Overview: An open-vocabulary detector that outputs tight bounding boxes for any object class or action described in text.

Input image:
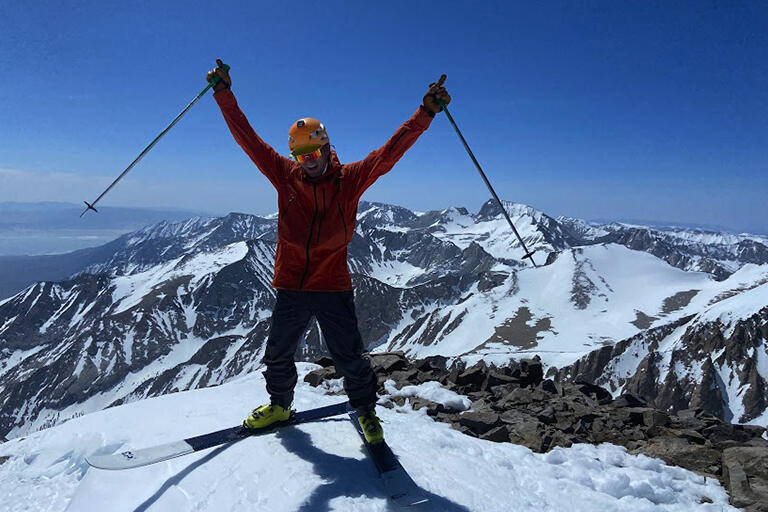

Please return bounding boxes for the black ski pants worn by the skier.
[263,290,378,408]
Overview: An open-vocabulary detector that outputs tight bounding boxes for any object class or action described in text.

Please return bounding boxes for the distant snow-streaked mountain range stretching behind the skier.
[0,198,768,437]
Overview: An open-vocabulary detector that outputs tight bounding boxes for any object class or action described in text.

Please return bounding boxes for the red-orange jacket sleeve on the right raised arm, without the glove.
[346,107,432,195]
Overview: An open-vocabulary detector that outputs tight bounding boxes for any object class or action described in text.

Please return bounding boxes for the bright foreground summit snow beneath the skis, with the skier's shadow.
[0,364,736,512]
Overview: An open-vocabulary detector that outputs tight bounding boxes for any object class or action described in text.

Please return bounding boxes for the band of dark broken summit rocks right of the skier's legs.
[305,352,768,512]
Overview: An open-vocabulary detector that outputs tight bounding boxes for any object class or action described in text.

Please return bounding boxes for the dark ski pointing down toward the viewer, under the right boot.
[347,407,429,507]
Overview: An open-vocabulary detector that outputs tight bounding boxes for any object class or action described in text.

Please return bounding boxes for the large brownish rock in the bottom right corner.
[722,447,768,512]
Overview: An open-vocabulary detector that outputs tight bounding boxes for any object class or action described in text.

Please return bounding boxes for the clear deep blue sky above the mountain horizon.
[0,0,768,233]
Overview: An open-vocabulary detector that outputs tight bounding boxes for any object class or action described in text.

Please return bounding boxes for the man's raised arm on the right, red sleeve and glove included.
[347,75,451,195]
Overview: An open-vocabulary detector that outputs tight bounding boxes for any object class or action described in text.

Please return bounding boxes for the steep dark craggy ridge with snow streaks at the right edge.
[551,306,768,423]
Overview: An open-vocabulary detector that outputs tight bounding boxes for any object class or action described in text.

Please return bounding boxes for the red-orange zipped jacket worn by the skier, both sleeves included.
[214,89,432,291]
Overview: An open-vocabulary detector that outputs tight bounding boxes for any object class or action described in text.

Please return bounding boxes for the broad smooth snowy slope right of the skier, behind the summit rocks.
[382,244,768,367]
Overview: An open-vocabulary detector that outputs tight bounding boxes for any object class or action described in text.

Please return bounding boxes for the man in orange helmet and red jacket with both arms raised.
[206,60,451,443]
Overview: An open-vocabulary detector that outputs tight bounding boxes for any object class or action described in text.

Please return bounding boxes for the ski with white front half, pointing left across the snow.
[85,402,347,470]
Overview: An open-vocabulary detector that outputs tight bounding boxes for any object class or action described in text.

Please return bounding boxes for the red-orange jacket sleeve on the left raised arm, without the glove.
[213,89,293,189]
